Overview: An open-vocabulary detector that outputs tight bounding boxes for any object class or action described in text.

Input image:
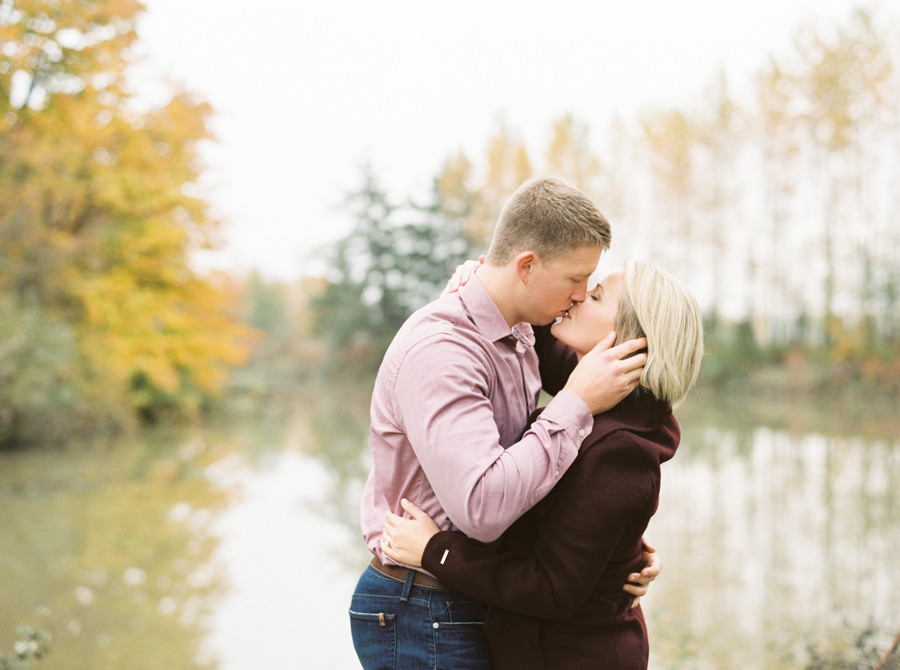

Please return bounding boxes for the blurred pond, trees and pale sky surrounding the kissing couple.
[0,0,900,670]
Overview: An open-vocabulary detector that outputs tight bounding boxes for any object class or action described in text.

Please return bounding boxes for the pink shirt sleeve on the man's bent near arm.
[393,341,593,542]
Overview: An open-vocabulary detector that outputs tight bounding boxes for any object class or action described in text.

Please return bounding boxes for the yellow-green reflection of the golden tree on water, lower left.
[0,432,232,669]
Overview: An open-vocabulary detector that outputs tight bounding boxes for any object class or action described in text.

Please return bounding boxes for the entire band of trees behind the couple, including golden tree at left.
[0,5,900,448]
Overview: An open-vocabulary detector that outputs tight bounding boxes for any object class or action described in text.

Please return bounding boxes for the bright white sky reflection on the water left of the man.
[208,451,368,670]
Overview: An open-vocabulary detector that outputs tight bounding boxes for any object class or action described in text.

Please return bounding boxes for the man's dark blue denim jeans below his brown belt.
[350,566,491,670]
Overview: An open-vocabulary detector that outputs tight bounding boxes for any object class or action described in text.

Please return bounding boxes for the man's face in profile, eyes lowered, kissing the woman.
[528,246,601,325]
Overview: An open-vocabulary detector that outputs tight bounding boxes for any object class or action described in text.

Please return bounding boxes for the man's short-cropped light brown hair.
[487,176,612,267]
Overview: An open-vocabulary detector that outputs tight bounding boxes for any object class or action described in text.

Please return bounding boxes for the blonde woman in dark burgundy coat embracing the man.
[382,261,703,670]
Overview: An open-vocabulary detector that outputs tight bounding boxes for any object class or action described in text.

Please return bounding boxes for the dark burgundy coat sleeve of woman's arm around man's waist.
[422,433,657,619]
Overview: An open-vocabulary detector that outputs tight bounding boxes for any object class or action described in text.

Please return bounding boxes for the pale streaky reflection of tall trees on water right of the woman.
[647,428,900,668]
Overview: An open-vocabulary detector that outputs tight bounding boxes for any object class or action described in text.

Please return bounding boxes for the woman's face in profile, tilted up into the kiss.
[552,272,623,358]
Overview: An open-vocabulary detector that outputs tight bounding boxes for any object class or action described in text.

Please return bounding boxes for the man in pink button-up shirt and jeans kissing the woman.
[350,177,658,670]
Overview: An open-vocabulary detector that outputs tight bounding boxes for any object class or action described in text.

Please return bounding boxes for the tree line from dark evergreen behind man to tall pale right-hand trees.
[316,10,900,388]
